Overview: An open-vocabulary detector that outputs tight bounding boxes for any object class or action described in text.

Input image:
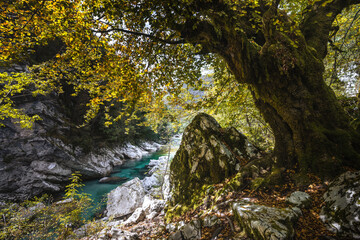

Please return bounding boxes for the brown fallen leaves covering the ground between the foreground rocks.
[131,172,337,240]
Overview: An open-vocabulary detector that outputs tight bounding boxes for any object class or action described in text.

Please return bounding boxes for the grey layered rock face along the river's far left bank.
[0,94,159,201]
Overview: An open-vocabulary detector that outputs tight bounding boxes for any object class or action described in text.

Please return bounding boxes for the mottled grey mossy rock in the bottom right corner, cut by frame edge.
[320,172,360,239]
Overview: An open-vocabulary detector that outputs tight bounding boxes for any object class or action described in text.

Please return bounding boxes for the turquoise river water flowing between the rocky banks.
[80,151,167,218]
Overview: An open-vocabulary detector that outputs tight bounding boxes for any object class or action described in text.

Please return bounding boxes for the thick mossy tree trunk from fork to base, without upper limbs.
[221,30,360,178]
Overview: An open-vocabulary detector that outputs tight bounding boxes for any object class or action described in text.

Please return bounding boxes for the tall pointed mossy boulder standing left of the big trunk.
[170,113,258,204]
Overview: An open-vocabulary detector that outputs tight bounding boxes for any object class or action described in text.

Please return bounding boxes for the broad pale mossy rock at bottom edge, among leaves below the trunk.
[232,200,301,240]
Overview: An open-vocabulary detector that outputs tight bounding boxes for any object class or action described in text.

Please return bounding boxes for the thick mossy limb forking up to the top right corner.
[300,0,360,59]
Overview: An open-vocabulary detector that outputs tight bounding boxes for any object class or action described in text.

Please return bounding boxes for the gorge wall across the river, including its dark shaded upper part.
[0,66,159,201]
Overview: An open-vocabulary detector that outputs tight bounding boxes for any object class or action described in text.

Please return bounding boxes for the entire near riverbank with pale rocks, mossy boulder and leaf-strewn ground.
[76,115,360,240]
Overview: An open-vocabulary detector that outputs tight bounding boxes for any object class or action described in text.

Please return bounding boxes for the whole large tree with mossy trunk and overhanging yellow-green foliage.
[0,0,360,177]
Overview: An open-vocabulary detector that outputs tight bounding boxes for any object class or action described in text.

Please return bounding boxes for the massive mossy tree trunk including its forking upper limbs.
[181,0,360,178]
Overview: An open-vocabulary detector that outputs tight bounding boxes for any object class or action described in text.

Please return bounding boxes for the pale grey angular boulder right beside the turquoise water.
[106,178,145,218]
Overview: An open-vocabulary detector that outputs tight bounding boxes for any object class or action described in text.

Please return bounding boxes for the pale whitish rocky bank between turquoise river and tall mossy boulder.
[71,156,170,239]
